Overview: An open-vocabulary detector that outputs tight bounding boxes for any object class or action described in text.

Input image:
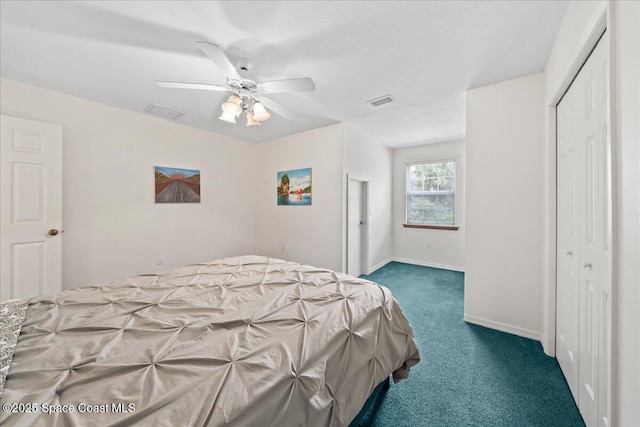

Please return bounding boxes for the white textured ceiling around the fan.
[0,0,568,147]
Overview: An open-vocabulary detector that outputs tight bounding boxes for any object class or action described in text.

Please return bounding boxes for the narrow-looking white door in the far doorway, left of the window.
[347,177,368,277]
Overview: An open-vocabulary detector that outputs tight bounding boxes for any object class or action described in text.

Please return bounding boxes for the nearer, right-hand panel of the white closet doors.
[578,30,611,426]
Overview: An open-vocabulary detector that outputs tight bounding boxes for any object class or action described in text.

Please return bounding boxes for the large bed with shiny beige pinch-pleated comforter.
[0,256,420,426]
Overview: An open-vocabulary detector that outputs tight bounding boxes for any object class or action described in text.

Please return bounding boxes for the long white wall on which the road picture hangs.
[0,79,255,289]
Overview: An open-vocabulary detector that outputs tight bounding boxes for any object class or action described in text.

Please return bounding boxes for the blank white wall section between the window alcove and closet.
[465,74,542,339]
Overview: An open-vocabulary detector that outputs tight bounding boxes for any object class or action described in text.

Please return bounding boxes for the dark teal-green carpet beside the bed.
[362,262,584,427]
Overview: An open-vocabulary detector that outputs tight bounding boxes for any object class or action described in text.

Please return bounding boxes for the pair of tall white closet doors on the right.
[557,33,611,426]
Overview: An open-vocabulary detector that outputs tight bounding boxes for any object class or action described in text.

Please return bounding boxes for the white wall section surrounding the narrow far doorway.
[342,123,393,271]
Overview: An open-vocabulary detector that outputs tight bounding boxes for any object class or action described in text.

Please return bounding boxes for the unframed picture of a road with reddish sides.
[155,166,200,203]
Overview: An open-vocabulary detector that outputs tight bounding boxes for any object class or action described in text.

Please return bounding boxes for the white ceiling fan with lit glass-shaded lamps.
[157,41,316,126]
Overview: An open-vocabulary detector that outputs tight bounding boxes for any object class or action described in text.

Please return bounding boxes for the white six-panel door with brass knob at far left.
[0,115,62,301]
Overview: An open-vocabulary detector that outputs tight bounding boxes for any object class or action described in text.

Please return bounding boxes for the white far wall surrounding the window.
[393,141,465,271]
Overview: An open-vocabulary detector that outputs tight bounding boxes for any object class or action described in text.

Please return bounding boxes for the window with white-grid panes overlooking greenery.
[406,160,456,226]
